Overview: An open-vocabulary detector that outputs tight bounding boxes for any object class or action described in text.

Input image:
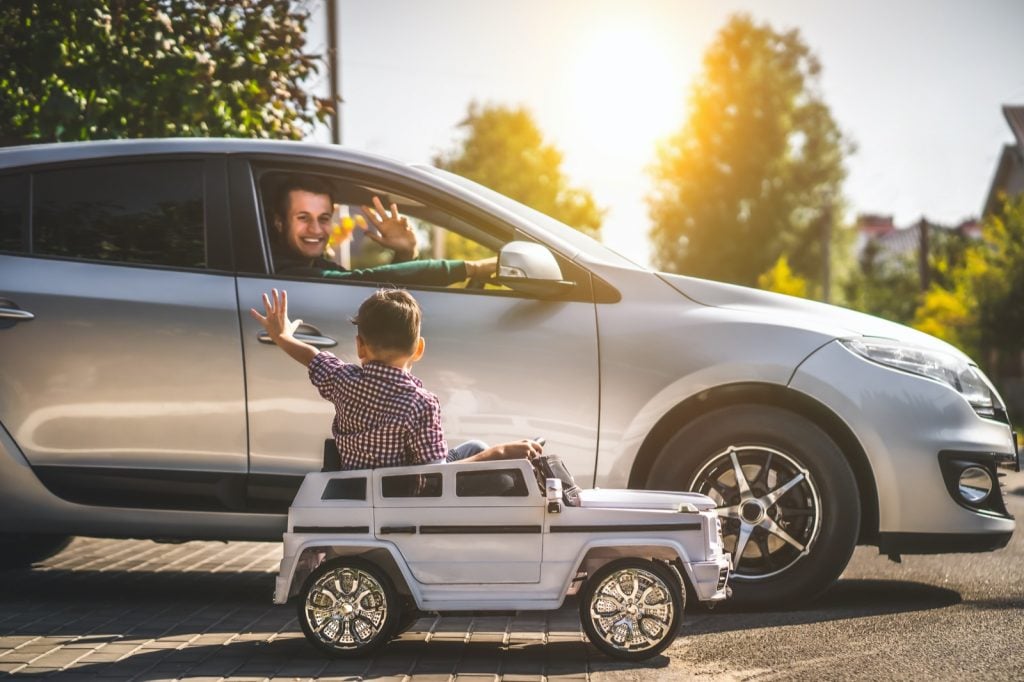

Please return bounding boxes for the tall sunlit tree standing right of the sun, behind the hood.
[648,15,852,288]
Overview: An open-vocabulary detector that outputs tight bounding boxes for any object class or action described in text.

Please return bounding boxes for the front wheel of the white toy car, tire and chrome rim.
[580,558,685,660]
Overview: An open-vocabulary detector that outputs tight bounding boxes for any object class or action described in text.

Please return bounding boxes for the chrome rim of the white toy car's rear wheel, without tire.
[303,566,389,651]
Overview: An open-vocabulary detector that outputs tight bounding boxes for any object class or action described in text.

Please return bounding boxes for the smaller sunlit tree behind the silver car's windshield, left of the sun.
[434,102,604,240]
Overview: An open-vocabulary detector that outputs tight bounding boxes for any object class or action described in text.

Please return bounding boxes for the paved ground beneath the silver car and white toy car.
[0,466,1024,682]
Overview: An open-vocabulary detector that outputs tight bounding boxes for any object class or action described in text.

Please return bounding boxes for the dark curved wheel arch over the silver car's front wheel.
[629,383,879,545]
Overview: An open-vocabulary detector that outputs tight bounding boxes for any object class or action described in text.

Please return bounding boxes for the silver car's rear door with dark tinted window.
[0,156,248,509]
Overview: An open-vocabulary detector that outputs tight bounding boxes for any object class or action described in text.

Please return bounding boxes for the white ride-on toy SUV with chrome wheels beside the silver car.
[274,450,730,659]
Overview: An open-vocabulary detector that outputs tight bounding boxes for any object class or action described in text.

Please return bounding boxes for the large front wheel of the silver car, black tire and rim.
[647,404,860,607]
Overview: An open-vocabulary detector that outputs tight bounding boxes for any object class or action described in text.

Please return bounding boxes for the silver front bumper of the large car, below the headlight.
[790,342,1018,540]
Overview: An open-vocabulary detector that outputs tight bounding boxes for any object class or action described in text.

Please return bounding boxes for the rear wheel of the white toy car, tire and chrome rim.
[298,559,401,657]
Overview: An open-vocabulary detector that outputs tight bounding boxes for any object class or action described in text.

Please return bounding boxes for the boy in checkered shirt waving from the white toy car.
[250,289,542,470]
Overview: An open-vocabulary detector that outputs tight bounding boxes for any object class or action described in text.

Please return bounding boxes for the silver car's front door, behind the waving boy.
[231,155,598,505]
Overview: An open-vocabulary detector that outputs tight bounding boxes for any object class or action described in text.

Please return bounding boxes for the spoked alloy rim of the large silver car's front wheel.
[690,445,821,582]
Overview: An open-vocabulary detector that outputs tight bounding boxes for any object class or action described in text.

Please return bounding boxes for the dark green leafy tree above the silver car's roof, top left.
[0,0,333,143]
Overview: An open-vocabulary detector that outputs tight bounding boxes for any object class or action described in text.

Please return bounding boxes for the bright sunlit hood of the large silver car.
[657,272,964,357]
